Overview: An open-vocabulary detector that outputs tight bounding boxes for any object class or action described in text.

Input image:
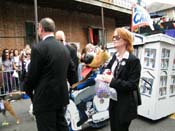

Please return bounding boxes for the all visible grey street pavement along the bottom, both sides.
[0,99,175,131]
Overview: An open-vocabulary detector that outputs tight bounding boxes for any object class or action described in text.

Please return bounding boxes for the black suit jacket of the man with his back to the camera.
[25,37,70,113]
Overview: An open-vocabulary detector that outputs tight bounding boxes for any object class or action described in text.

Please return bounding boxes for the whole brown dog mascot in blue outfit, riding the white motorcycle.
[72,44,109,126]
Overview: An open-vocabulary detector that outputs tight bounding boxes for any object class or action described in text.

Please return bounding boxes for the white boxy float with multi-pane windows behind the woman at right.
[134,34,175,120]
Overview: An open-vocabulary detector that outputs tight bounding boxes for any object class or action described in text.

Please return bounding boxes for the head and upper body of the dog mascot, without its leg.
[72,44,109,90]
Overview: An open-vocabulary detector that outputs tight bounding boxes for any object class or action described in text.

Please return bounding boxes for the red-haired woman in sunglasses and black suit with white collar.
[103,28,141,131]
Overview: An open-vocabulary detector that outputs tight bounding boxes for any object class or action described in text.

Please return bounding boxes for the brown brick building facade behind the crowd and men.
[0,0,131,52]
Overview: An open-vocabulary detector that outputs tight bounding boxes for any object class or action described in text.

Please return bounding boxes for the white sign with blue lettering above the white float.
[131,5,154,31]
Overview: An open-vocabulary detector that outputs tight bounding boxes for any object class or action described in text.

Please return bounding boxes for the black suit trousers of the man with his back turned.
[35,108,69,131]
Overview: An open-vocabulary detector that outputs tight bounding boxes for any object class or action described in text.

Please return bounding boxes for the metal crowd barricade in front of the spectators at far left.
[0,70,21,96]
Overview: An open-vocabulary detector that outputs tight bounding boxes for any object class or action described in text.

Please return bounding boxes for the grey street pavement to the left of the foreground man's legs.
[0,99,37,131]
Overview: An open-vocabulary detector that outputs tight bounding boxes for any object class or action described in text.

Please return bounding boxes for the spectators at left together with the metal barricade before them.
[0,45,31,94]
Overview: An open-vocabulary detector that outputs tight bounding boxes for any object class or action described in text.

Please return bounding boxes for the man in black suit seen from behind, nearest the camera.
[25,18,70,131]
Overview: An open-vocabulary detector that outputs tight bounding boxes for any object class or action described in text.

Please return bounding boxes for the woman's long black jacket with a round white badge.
[107,54,141,122]
